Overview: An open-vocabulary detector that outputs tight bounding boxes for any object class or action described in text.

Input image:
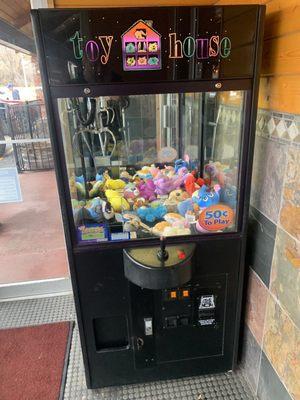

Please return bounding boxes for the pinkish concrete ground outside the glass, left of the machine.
[0,170,69,284]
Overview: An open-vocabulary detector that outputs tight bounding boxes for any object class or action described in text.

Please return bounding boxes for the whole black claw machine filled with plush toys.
[32,5,264,388]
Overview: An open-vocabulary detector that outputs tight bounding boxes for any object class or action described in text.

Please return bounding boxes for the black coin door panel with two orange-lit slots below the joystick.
[130,275,226,368]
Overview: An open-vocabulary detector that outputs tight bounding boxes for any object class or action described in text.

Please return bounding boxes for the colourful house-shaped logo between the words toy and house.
[122,20,162,71]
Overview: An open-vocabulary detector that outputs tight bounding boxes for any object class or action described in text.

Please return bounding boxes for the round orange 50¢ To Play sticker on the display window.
[199,204,234,231]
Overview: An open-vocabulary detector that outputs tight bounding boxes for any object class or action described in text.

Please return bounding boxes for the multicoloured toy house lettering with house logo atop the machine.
[70,20,231,71]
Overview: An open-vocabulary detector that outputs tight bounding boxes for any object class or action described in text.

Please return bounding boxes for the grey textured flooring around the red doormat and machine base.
[0,296,255,400]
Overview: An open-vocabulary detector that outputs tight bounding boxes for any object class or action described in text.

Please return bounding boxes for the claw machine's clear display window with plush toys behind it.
[58,91,245,244]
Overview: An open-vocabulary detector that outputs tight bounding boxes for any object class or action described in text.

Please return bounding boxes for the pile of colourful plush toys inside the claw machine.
[70,159,237,236]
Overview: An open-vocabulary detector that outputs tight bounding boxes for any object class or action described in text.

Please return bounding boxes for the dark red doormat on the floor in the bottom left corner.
[0,321,74,400]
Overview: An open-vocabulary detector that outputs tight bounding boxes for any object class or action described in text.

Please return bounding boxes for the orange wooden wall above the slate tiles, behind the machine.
[54,0,300,114]
